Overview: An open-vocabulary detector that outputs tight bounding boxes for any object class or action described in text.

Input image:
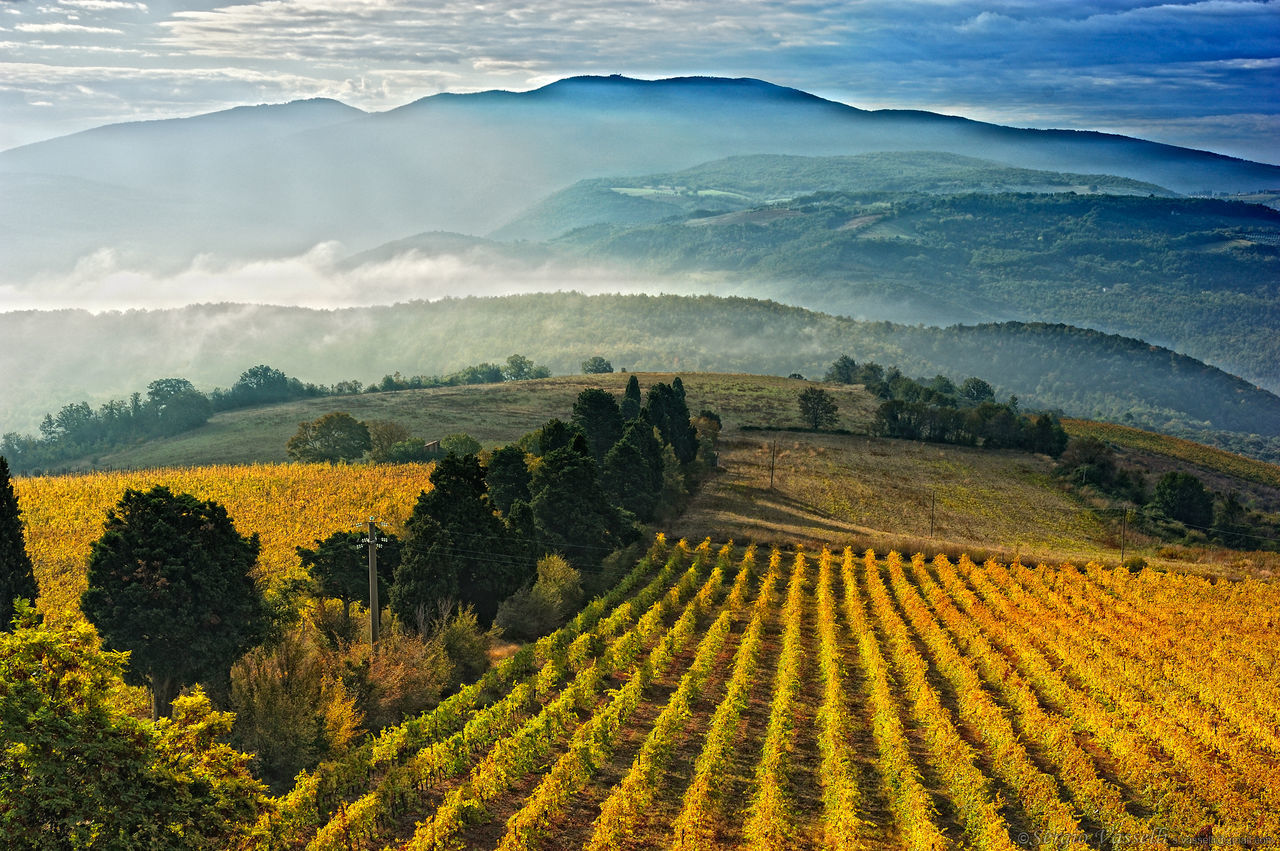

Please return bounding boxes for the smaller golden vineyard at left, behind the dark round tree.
[14,465,431,621]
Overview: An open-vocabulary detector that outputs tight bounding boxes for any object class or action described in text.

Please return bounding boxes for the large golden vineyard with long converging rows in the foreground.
[256,536,1280,850]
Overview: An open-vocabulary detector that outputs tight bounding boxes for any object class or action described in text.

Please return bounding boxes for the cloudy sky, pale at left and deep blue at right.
[0,0,1280,163]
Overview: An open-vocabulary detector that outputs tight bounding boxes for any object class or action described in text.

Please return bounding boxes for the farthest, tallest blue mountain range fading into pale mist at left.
[0,77,1280,279]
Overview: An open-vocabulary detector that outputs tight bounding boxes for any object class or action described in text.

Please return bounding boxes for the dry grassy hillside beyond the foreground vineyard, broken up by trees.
[57,372,1280,578]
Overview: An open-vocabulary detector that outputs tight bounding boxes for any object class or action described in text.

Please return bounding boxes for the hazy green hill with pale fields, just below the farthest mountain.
[493,151,1172,241]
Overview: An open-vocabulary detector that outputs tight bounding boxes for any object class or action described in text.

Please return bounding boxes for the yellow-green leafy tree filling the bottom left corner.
[0,604,266,850]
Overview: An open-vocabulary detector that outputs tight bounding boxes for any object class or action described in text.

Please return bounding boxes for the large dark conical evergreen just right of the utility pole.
[390,454,532,627]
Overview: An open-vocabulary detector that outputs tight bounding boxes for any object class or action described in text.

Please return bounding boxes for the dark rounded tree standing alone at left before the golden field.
[81,486,270,717]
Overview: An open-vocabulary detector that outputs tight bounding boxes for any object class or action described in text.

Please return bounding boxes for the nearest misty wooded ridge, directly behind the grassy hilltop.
[0,293,1280,458]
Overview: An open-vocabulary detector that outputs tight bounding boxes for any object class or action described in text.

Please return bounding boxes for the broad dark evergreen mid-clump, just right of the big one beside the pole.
[530,447,621,567]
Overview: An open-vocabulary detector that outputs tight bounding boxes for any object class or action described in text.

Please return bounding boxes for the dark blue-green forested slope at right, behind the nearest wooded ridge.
[552,193,1280,389]
